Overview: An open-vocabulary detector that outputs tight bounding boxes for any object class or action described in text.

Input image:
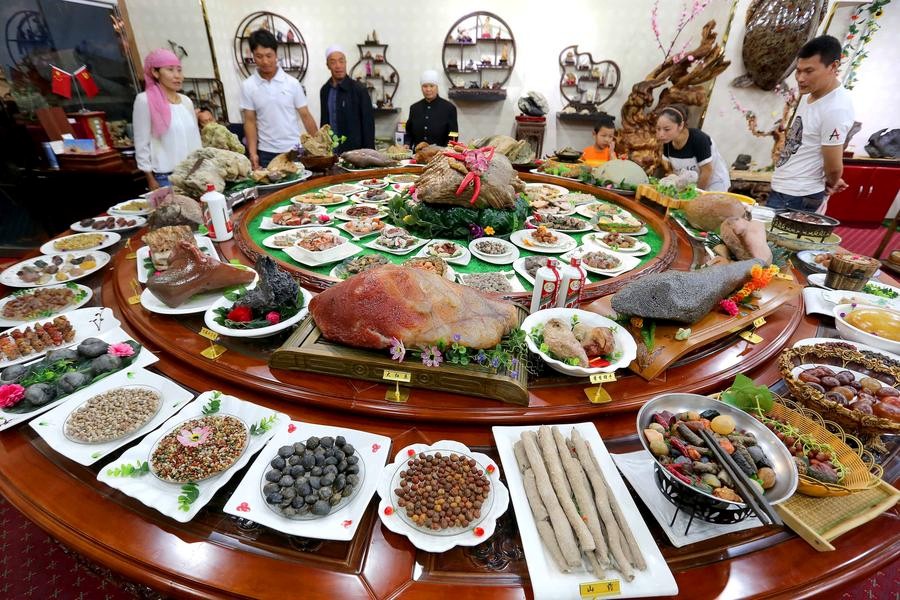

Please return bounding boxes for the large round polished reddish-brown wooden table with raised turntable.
[0,171,900,599]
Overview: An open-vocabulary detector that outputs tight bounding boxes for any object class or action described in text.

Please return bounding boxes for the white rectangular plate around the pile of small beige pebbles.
[30,369,194,465]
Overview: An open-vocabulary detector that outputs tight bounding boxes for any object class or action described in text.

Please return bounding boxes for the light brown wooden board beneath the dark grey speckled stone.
[586,278,802,381]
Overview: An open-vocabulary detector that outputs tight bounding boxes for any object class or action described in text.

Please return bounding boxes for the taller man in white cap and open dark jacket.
[319,44,375,153]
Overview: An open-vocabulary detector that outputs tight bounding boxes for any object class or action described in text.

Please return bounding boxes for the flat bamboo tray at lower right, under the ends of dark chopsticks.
[775,479,900,552]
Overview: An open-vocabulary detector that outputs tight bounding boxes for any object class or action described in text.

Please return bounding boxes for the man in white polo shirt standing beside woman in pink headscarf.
[241,29,318,169]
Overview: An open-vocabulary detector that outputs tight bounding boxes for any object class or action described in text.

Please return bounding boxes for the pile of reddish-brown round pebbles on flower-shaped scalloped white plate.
[394,452,491,531]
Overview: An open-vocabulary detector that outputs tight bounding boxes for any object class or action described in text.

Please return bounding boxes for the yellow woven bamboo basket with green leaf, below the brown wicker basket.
[766,397,884,498]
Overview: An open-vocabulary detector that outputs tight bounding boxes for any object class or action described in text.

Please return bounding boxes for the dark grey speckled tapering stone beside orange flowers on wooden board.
[612,259,763,323]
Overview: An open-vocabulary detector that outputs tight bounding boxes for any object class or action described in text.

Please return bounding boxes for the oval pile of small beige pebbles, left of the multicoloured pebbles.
[65,386,162,444]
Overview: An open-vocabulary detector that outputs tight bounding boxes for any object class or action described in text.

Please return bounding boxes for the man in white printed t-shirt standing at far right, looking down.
[766,35,853,211]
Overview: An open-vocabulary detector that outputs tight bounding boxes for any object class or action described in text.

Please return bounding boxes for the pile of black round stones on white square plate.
[262,435,362,518]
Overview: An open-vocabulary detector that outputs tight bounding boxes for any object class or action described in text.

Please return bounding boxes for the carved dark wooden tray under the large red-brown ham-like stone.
[269,308,528,406]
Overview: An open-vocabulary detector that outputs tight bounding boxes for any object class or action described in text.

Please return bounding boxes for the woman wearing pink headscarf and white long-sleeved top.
[132,49,200,190]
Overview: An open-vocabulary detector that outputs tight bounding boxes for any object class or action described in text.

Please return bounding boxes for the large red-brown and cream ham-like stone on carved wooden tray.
[309,264,518,349]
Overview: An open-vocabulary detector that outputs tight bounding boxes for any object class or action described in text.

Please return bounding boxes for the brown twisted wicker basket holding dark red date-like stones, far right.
[778,344,900,447]
